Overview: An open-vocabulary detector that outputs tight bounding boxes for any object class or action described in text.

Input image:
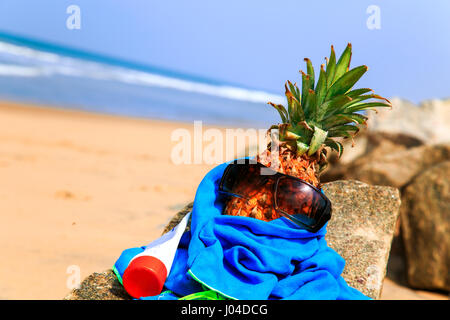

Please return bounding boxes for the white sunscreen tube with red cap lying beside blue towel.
[122,212,191,298]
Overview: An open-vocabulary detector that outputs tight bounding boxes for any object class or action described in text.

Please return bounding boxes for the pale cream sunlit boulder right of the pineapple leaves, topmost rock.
[368,98,450,144]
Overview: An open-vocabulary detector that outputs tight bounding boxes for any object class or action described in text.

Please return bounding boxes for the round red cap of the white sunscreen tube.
[122,256,167,299]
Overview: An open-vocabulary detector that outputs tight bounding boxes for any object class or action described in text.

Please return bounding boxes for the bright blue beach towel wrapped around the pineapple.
[114,163,370,300]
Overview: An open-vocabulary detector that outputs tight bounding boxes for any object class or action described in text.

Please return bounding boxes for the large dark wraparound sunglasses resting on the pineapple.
[219,160,331,232]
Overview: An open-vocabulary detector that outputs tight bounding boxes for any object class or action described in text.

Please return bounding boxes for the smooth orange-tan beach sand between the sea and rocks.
[0,102,444,299]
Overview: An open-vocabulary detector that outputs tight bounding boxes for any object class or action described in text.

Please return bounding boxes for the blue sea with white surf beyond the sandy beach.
[0,32,285,128]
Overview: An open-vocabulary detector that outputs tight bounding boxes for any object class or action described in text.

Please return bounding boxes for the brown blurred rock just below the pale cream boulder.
[322,141,450,188]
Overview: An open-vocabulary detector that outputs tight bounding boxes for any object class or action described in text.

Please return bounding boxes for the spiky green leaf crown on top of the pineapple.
[269,43,391,170]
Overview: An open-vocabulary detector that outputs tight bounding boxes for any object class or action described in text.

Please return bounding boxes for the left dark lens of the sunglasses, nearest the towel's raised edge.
[221,164,274,198]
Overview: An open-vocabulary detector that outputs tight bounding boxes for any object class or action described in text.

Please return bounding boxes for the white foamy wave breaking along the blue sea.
[0,41,284,103]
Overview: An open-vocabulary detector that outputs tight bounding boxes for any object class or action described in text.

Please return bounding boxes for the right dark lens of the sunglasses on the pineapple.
[276,178,327,226]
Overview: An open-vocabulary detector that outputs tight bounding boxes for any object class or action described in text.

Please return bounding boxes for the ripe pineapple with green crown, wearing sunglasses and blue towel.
[224,43,391,221]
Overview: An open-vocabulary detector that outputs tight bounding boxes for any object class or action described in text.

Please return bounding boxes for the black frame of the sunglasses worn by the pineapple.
[219,162,332,232]
